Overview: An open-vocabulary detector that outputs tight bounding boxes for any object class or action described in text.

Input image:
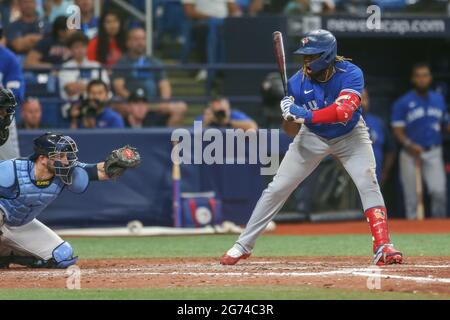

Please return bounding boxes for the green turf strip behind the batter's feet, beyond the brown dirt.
[67,234,450,259]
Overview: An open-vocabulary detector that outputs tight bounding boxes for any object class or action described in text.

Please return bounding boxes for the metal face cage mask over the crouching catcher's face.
[48,136,78,185]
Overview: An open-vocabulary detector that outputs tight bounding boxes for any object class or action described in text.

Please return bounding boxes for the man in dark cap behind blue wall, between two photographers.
[125,88,169,128]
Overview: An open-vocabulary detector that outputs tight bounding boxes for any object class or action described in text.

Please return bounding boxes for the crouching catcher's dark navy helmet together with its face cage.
[30,132,78,184]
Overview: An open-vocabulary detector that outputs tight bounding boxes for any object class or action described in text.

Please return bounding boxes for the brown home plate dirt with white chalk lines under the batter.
[0,257,450,295]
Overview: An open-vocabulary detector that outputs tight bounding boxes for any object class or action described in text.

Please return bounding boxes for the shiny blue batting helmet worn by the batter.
[294,29,337,73]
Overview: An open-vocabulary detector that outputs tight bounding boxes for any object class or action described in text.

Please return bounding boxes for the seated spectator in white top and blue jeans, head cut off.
[182,0,242,81]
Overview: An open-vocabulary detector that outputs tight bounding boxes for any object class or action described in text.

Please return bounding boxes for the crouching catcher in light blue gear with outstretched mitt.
[0,133,140,268]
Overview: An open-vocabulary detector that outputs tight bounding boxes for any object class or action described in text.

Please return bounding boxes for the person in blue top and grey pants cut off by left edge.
[0,24,25,160]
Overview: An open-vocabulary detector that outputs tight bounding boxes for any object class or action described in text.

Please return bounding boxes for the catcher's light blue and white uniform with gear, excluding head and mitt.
[0,135,96,268]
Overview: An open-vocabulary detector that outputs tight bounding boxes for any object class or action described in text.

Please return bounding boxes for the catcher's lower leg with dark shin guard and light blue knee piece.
[0,241,78,269]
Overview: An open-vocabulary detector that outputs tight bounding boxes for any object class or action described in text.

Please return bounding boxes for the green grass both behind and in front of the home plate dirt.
[0,234,450,300]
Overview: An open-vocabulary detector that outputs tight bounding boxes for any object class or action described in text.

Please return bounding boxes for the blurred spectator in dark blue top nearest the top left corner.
[6,0,48,54]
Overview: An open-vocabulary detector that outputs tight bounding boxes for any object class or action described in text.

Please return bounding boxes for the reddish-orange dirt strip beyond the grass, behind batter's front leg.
[271,219,450,235]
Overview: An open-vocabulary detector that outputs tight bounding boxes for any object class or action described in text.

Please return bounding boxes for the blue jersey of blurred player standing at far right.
[391,90,449,148]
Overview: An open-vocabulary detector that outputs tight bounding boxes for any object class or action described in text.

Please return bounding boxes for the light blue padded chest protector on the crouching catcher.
[0,160,64,226]
